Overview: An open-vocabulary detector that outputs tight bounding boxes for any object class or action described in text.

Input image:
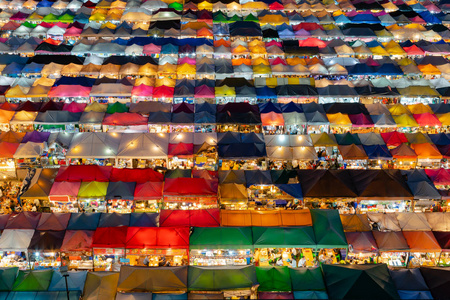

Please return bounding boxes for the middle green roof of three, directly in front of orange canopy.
[252,226,316,248]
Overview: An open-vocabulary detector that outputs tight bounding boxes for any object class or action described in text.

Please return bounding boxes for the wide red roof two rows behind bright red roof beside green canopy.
[164,177,218,196]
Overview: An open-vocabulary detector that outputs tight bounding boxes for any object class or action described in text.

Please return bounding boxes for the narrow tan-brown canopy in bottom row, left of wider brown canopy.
[83,272,119,300]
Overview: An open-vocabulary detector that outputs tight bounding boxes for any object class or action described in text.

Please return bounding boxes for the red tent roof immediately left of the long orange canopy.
[159,209,220,227]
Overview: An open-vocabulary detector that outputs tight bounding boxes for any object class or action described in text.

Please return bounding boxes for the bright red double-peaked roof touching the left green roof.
[126,227,189,249]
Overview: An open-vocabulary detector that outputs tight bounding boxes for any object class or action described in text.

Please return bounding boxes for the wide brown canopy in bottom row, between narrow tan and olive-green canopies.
[118,266,188,292]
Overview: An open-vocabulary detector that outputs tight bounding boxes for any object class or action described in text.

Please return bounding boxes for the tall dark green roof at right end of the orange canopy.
[310,209,348,248]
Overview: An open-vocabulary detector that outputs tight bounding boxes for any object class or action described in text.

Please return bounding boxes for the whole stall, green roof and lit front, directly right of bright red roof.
[189,227,253,266]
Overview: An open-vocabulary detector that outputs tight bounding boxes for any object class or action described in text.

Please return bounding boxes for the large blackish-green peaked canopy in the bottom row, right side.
[322,264,399,299]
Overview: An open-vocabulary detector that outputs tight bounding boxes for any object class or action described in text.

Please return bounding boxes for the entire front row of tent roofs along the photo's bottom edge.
[1,264,449,300]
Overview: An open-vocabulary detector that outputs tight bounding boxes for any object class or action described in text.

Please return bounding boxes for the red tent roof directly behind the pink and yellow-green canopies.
[55,165,112,182]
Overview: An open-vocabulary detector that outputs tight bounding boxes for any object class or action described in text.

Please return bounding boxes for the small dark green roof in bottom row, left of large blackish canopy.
[289,268,325,291]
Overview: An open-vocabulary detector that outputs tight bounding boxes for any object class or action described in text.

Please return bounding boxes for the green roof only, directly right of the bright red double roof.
[189,227,253,249]
